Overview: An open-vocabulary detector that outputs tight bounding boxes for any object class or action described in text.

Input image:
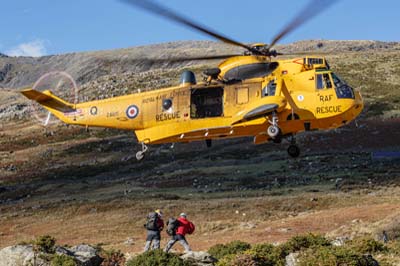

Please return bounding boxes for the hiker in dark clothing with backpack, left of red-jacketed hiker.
[144,210,164,252]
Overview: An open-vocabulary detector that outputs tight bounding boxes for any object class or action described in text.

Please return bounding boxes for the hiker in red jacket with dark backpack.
[164,213,195,252]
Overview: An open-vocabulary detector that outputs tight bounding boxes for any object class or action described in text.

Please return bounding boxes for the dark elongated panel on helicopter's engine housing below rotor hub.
[224,63,274,80]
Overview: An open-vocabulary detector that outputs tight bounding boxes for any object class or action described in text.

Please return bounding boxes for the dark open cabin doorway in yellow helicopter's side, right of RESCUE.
[190,87,224,118]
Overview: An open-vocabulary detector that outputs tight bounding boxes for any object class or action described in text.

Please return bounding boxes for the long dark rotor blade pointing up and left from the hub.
[121,0,253,51]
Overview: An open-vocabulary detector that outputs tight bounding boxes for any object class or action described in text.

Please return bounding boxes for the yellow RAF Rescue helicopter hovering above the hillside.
[21,0,363,160]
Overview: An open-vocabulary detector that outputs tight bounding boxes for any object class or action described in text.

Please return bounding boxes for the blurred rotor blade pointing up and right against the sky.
[268,0,338,50]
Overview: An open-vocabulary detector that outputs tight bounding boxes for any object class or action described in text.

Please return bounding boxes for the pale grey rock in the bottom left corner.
[0,245,49,266]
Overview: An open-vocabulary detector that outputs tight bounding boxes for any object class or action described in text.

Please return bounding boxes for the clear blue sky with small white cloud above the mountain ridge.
[0,0,400,56]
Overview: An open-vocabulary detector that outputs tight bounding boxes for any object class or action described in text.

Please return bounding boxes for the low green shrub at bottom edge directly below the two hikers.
[126,250,192,266]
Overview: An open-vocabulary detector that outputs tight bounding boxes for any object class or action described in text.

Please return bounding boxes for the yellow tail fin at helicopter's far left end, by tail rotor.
[21,89,76,113]
